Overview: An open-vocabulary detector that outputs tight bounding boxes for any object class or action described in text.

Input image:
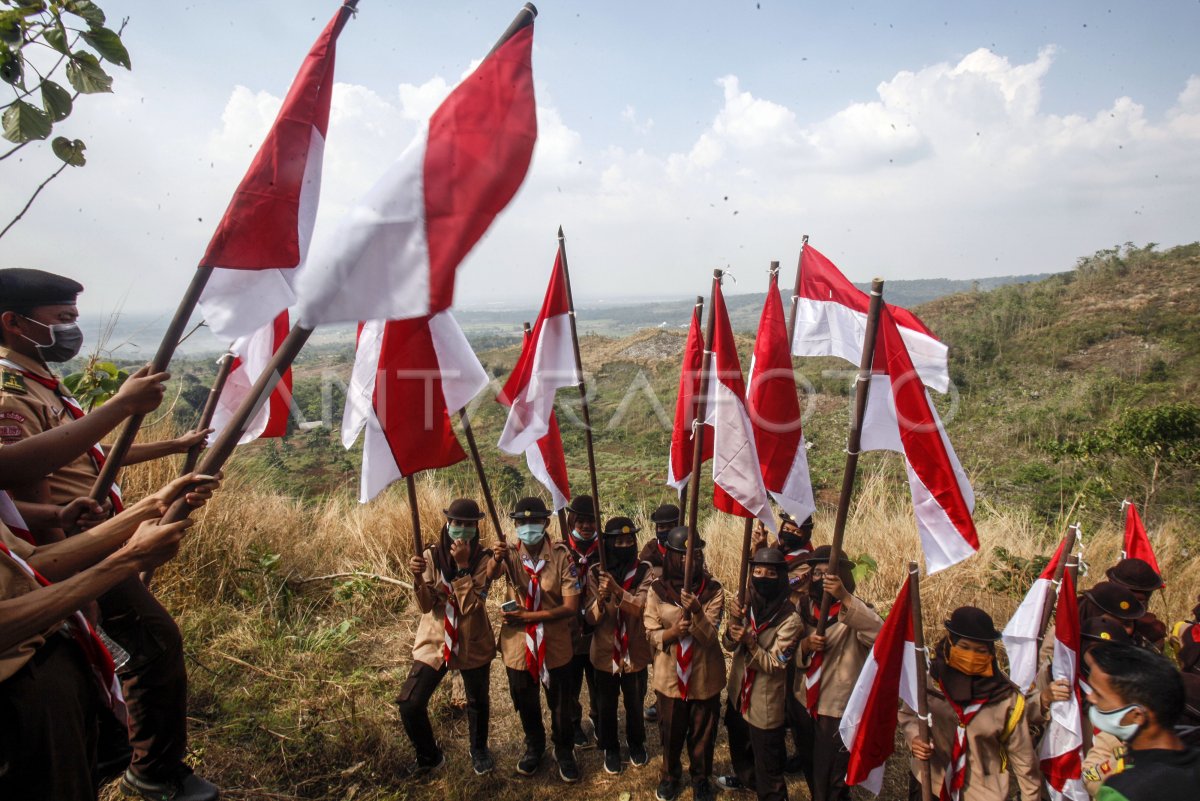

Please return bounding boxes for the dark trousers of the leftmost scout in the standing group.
[396,662,492,765]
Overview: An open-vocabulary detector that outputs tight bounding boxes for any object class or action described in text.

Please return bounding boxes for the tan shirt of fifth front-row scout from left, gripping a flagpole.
[646,579,725,700]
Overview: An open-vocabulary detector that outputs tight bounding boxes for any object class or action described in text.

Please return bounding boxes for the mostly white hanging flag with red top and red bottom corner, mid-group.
[704,282,779,531]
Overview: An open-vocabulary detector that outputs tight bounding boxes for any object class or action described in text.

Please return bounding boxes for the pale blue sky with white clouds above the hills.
[0,0,1200,330]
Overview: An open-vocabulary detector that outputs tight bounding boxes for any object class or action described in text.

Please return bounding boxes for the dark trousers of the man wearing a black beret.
[98,577,187,779]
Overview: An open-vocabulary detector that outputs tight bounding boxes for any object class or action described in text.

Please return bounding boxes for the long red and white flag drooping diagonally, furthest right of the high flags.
[862,307,979,573]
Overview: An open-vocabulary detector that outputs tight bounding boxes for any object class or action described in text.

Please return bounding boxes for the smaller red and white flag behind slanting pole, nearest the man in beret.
[209,309,292,445]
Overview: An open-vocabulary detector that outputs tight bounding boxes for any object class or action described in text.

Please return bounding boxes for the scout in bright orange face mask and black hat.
[900,607,1042,801]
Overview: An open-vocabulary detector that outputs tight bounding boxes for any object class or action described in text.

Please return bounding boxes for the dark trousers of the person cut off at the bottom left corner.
[0,634,103,801]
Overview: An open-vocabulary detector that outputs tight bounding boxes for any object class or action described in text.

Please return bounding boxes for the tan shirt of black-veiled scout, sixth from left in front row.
[721,608,804,729]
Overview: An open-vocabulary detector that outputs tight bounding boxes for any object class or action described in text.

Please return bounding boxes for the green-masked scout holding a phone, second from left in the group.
[491,498,581,783]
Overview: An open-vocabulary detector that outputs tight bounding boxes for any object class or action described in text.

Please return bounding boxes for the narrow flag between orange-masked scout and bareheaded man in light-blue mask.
[1038,571,1090,801]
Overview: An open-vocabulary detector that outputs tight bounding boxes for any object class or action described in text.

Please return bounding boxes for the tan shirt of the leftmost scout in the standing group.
[413,548,496,670]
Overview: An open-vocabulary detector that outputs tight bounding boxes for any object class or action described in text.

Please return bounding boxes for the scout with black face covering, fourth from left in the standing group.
[583,517,653,773]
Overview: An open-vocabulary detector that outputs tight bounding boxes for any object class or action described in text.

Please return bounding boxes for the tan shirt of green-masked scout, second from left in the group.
[499,532,580,670]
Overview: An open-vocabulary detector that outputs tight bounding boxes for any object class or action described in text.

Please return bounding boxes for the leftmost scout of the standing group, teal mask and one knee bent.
[397,498,496,776]
